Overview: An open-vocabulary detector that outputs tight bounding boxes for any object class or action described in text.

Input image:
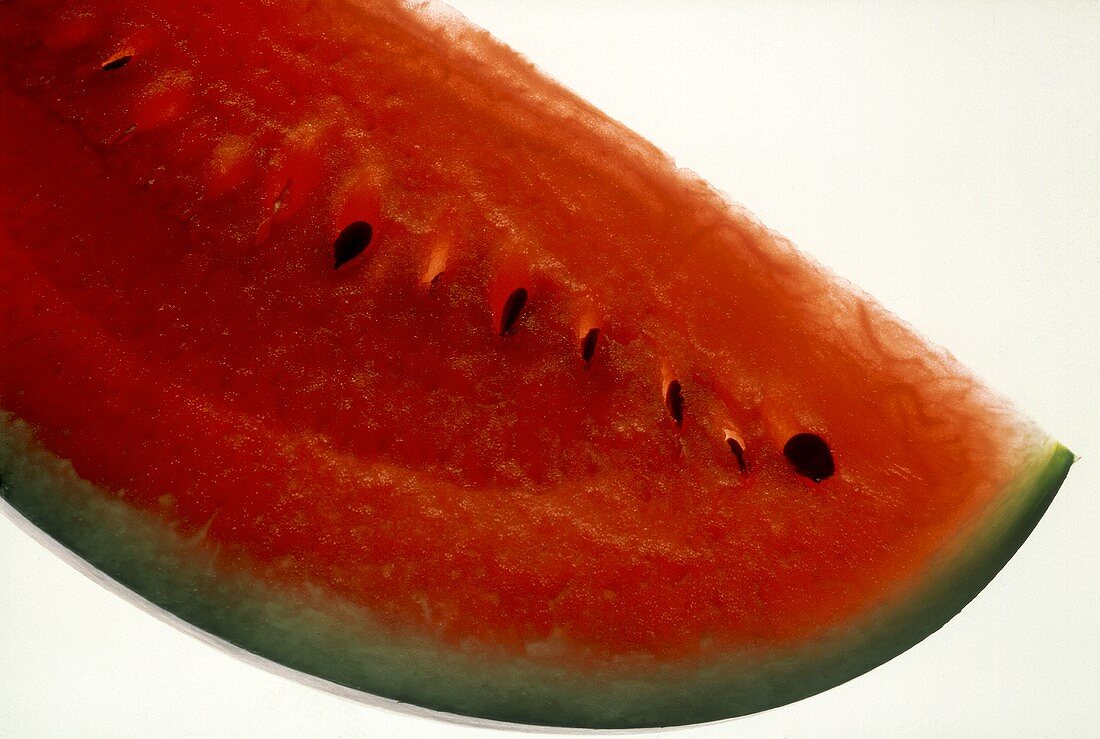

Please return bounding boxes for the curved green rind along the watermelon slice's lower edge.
[0,412,1075,728]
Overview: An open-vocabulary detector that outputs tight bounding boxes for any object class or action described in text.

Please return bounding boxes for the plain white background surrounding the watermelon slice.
[0,0,1100,739]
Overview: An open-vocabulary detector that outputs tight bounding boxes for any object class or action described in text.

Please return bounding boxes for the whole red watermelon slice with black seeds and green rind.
[0,0,1073,727]
